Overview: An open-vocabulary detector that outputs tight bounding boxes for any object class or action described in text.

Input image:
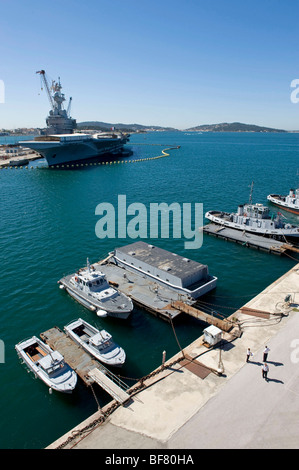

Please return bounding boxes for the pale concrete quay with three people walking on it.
[47,264,299,450]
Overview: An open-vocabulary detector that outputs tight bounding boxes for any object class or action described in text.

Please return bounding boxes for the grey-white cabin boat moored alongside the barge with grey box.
[58,258,133,319]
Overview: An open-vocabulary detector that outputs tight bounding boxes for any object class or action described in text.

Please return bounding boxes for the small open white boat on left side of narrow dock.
[15,336,77,393]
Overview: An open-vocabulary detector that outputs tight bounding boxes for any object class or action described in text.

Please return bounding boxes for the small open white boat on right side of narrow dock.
[64,318,126,366]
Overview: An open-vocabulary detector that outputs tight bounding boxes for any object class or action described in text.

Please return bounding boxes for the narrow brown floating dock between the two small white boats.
[40,326,130,403]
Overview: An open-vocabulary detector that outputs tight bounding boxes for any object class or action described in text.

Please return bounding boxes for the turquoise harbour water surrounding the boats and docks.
[0,132,299,449]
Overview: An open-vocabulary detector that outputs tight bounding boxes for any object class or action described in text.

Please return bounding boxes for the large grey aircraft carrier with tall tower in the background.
[18,70,129,166]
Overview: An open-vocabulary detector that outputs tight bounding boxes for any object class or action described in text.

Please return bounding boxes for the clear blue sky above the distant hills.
[0,0,299,130]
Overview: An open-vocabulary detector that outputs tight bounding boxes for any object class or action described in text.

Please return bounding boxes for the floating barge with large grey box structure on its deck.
[59,241,217,321]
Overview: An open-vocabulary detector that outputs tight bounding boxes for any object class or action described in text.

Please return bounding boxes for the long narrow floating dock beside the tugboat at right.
[202,223,299,255]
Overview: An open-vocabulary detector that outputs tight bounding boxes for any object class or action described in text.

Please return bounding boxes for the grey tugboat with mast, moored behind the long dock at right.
[205,183,299,241]
